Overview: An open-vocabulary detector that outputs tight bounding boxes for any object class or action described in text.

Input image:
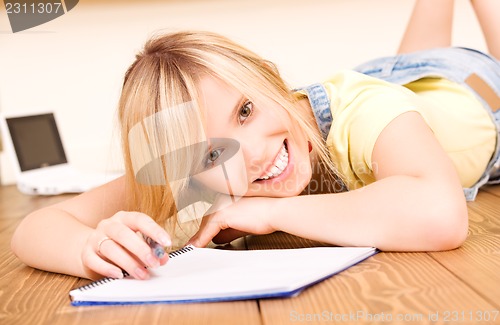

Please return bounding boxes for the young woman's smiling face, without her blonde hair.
[198,76,312,197]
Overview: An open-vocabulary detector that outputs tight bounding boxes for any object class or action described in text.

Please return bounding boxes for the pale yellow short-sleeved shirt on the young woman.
[324,71,496,190]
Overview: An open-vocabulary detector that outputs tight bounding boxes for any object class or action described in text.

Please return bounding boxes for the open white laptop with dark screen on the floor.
[0,112,119,195]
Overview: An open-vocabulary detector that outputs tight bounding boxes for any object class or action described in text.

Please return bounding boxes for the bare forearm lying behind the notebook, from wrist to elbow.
[272,176,467,251]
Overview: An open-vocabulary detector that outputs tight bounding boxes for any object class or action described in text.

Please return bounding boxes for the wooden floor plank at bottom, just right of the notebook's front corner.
[260,253,495,324]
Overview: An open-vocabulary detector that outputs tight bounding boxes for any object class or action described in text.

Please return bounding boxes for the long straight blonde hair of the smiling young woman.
[119,31,340,235]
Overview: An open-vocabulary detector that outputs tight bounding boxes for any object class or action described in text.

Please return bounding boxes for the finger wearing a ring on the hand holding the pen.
[96,235,149,280]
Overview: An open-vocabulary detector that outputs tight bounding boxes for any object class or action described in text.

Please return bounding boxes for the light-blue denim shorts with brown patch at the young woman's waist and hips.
[354,47,500,201]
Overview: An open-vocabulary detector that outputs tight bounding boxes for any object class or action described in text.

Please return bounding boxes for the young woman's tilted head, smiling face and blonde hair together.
[118,31,334,233]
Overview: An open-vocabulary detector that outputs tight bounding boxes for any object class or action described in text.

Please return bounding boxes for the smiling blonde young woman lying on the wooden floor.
[12,0,500,279]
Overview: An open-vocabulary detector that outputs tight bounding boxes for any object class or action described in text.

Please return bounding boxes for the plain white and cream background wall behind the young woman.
[0,0,485,184]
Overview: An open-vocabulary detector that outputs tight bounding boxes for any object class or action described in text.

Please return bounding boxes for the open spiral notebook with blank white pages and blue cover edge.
[69,246,377,306]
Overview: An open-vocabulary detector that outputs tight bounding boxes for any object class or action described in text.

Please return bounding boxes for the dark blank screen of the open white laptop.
[6,113,67,171]
